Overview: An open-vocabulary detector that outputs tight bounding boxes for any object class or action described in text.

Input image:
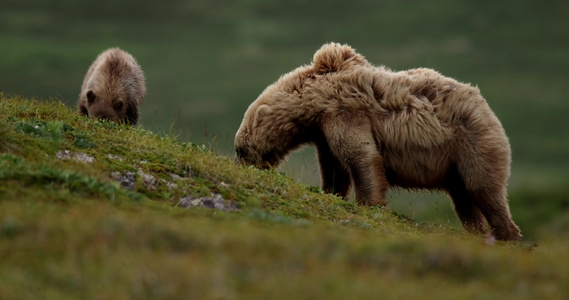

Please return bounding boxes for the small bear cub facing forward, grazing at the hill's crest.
[78,48,146,125]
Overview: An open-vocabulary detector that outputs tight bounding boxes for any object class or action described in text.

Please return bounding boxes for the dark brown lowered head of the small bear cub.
[79,90,138,125]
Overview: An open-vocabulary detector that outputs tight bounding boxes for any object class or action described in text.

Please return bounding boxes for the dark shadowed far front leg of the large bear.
[316,142,352,198]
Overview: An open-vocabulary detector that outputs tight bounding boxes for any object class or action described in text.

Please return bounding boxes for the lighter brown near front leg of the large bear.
[324,116,389,206]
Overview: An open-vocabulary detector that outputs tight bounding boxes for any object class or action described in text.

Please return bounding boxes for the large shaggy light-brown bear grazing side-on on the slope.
[235,43,521,240]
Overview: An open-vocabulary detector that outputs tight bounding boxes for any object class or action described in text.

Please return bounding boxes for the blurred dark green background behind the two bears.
[0,0,569,237]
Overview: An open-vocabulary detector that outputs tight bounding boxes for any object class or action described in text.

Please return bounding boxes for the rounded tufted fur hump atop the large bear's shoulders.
[312,43,368,74]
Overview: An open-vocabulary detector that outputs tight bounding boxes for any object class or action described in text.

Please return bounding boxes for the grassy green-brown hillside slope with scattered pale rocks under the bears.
[0,94,569,299]
